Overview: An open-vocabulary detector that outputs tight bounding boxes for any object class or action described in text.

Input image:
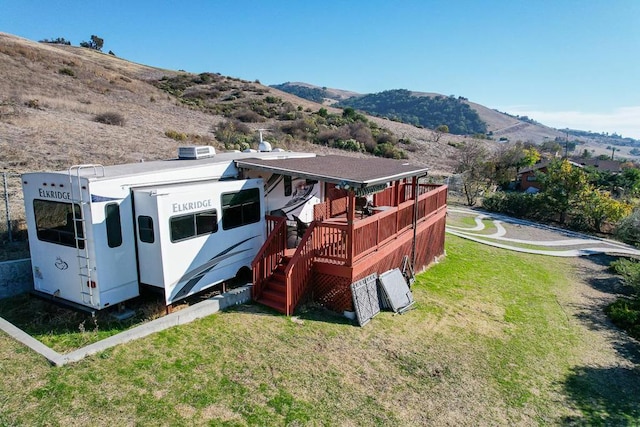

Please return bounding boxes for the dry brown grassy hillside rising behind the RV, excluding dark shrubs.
[0,33,500,175]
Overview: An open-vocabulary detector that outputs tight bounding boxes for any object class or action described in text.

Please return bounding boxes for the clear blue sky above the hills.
[0,0,640,138]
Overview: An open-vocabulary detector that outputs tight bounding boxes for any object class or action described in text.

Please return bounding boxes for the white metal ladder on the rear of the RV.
[69,164,104,307]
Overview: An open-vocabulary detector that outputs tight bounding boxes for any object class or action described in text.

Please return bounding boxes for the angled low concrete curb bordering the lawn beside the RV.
[0,285,252,366]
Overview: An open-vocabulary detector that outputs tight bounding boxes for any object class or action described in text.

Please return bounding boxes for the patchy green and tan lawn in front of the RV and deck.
[0,236,640,426]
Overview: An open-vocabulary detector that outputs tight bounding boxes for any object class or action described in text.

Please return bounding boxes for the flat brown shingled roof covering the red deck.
[236,155,427,191]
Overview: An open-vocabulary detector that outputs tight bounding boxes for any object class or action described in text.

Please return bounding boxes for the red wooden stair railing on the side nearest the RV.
[251,215,287,299]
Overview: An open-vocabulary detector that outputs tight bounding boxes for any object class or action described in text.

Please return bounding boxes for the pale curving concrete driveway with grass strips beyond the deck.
[446,208,640,257]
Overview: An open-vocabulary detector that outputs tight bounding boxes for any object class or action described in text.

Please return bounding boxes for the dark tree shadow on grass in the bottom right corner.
[563,367,640,425]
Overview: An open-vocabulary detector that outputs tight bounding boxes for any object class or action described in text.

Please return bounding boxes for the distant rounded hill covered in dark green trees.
[338,89,487,135]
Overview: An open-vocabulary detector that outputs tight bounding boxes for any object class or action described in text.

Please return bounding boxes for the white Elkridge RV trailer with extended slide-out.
[22,147,323,310]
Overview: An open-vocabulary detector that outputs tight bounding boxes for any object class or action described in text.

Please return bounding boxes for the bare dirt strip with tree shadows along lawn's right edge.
[559,255,640,425]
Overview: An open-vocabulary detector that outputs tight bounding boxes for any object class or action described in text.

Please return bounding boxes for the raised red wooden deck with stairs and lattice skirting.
[253,179,447,315]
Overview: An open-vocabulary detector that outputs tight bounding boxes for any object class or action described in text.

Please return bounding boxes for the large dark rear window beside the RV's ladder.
[33,199,84,249]
